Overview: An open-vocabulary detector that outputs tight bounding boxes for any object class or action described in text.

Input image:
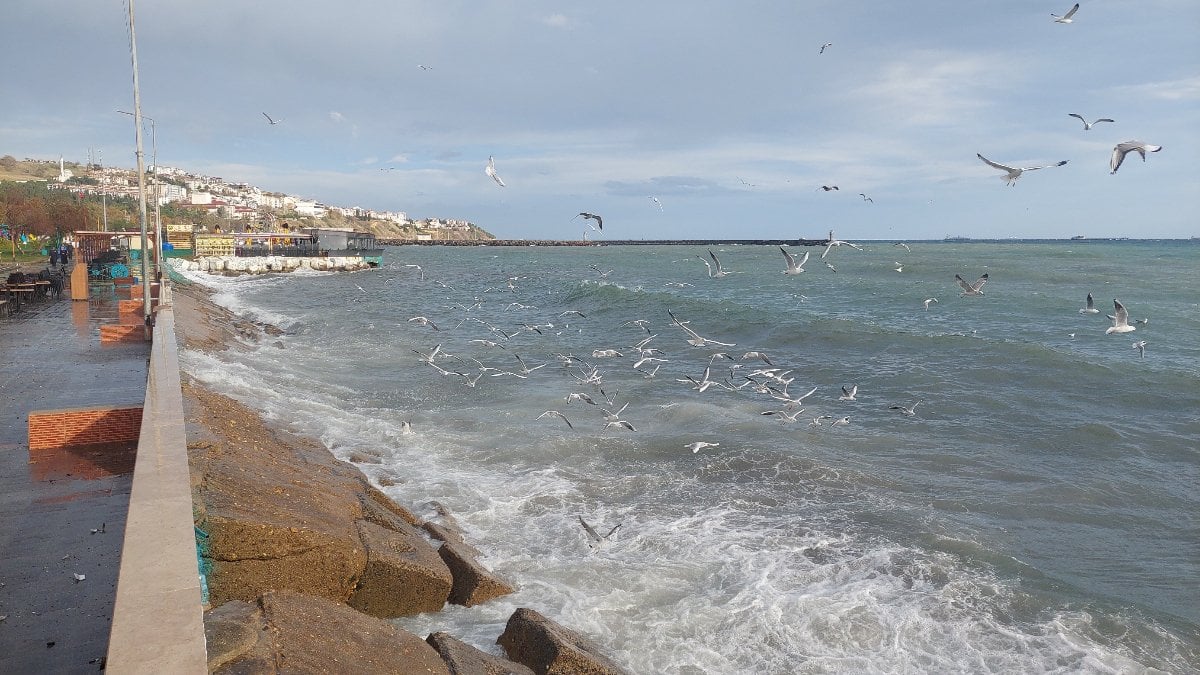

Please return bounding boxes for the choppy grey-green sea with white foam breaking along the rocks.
[175,240,1200,674]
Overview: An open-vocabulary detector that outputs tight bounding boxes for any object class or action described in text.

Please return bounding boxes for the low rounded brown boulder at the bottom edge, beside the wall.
[204,591,450,675]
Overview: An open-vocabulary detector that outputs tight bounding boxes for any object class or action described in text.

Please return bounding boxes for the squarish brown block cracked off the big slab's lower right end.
[348,520,455,617]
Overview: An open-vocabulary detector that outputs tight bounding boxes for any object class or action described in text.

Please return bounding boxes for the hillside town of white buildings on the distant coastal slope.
[9,157,492,240]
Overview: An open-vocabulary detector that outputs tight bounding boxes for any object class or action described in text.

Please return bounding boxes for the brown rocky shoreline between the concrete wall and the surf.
[174,285,624,674]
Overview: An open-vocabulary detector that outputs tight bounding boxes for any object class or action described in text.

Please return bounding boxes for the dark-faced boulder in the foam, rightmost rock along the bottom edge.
[496,608,625,675]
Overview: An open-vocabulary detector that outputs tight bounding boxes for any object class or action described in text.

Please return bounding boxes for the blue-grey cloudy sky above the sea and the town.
[0,0,1200,240]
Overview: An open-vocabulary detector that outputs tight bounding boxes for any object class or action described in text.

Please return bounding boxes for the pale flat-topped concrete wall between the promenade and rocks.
[107,302,208,674]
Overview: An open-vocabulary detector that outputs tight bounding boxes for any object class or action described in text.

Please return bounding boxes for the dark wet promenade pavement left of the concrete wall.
[0,273,150,673]
